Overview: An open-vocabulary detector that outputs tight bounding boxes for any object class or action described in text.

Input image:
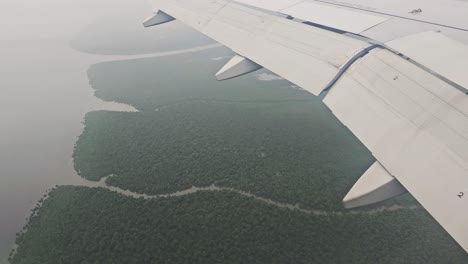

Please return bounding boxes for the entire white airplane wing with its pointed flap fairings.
[144,0,468,251]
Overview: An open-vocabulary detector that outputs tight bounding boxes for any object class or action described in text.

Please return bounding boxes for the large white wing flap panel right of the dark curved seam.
[324,49,468,249]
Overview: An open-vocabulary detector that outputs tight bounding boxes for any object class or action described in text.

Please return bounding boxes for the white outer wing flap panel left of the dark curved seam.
[148,0,370,95]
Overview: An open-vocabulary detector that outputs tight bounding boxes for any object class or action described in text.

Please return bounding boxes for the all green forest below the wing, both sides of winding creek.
[12,46,462,264]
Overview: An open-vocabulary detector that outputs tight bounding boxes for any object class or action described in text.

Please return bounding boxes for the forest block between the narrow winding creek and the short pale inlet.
[75,103,373,210]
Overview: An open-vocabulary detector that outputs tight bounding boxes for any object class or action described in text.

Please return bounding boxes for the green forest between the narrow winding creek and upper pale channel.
[74,49,416,210]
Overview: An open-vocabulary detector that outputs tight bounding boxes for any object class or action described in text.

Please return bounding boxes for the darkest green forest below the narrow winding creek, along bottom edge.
[12,187,468,264]
